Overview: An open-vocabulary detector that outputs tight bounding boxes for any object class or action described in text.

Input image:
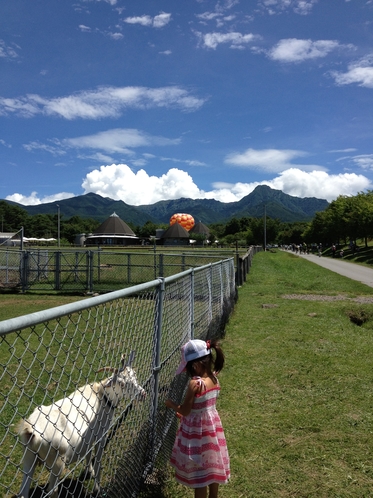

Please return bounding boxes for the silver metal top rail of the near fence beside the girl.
[0,258,233,336]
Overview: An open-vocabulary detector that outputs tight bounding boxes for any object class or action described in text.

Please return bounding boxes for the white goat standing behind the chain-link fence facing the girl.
[18,358,145,498]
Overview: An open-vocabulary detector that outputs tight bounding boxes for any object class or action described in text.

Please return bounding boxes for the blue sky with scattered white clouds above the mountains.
[0,0,373,205]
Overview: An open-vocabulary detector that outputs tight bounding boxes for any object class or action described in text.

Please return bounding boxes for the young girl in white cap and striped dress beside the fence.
[166,339,230,498]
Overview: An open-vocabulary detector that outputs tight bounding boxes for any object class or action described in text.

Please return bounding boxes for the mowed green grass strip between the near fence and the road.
[163,251,373,498]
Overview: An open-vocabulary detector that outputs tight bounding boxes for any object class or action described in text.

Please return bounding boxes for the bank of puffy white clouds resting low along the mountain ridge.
[6,164,372,206]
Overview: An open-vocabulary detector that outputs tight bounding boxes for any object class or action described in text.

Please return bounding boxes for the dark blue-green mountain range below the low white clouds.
[6,185,329,226]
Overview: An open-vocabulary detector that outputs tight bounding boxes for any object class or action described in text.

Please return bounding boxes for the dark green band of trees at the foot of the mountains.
[0,191,373,246]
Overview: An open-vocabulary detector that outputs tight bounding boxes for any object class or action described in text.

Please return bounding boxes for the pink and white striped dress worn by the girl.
[170,377,230,488]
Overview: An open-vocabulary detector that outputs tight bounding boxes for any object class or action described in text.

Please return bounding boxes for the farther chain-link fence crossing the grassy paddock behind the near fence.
[0,248,241,292]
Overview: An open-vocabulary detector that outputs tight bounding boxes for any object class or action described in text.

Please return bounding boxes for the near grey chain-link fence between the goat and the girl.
[0,258,236,498]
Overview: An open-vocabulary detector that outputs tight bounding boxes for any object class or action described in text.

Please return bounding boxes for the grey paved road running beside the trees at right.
[290,254,373,287]
